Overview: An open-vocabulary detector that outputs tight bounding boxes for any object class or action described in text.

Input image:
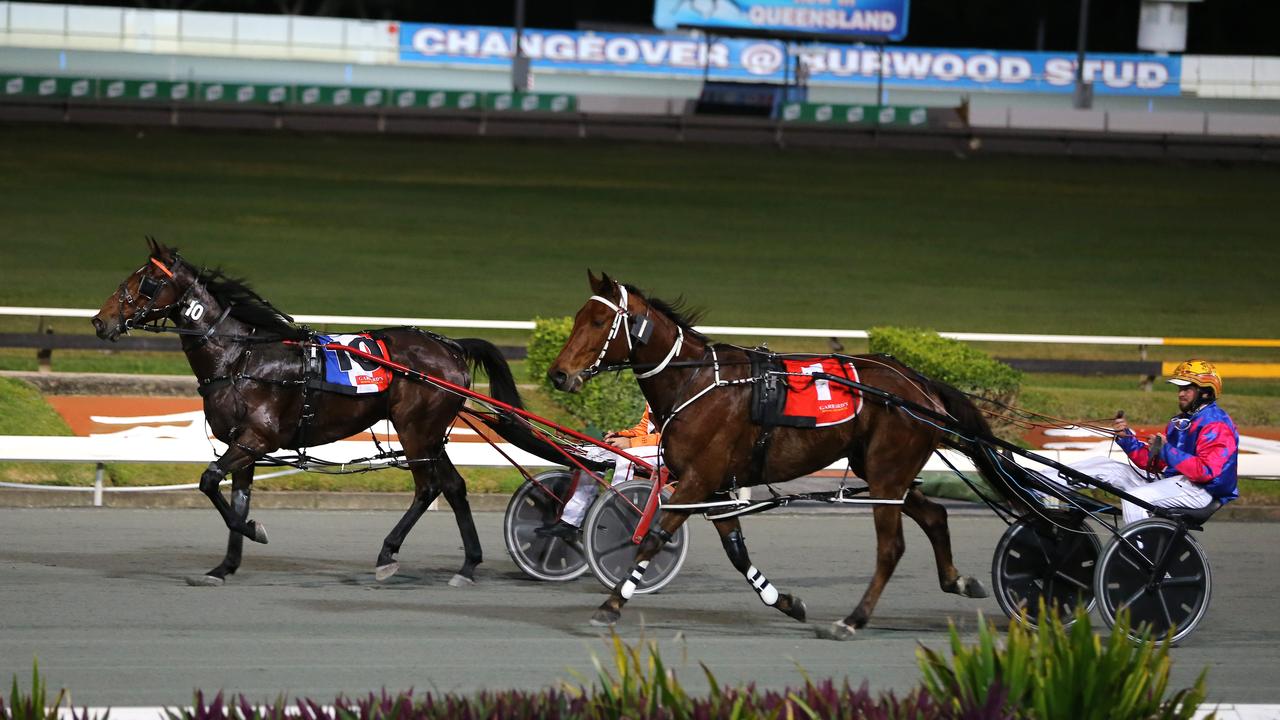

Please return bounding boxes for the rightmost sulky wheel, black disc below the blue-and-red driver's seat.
[1094,519,1213,643]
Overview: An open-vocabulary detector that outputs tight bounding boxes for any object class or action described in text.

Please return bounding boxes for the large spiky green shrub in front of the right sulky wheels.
[916,601,1204,720]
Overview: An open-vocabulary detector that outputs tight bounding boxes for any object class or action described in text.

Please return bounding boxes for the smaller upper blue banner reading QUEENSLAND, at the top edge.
[653,0,908,40]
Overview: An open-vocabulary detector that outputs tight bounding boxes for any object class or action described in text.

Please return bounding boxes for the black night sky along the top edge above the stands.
[55,0,1280,55]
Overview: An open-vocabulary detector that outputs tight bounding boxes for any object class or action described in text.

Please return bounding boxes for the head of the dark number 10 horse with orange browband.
[91,237,193,342]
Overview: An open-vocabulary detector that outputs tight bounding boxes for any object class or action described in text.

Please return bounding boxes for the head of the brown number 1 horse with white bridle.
[547,270,646,392]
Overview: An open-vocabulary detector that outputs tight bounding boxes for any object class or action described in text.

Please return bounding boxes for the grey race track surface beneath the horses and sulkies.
[0,509,1280,706]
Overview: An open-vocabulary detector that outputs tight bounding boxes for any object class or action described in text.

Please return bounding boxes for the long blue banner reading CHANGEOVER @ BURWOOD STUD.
[399,23,1181,96]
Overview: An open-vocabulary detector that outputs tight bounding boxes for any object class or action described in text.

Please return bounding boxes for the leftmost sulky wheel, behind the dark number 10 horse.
[502,469,586,582]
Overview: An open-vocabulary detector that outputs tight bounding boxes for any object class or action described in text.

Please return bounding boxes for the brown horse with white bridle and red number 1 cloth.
[548,273,1004,639]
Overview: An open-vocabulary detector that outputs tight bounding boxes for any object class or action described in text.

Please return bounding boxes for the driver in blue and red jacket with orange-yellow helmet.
[1071,360,1240,524]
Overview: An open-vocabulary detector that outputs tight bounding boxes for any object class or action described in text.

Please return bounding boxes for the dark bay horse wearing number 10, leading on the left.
[92,238,521,585]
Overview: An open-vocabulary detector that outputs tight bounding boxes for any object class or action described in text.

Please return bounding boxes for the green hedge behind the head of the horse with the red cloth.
[526,318,644,434]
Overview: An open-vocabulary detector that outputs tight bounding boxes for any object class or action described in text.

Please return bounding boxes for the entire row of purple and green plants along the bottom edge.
[0,611,1204,720]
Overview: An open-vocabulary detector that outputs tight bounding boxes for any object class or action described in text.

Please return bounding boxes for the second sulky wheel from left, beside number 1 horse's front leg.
[582,480,689,594]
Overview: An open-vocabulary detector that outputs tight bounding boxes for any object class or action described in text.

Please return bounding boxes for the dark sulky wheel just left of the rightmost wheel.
[991,518,1102,628]
